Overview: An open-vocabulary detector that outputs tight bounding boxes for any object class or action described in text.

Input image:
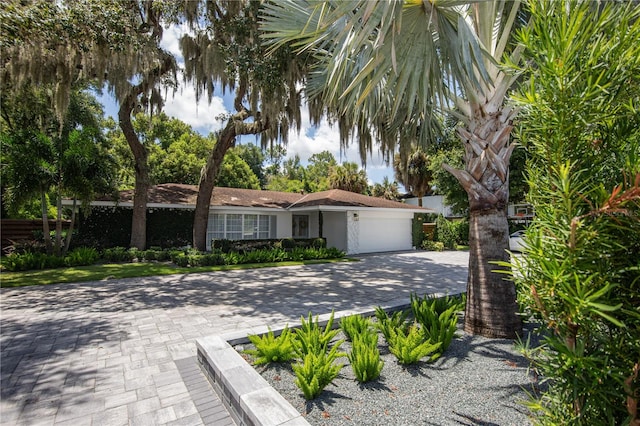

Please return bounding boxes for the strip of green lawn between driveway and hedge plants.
[0,259,351,287]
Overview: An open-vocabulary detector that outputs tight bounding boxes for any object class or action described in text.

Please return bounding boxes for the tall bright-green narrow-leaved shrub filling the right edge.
[513,0,640,425]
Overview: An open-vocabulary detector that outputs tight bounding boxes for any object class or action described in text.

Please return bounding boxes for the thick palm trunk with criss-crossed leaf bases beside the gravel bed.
[443,108,522,339]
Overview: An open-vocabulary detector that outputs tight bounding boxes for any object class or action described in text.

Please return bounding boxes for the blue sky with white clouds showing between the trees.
[98,26,395,184]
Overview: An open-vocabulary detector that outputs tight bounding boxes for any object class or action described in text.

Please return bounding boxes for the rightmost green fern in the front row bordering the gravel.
[387,324,442,364]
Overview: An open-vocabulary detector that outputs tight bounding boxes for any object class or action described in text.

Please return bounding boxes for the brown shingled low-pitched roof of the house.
[97,183,421,210]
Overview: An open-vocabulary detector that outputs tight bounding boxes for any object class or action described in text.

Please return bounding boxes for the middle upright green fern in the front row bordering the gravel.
[343,327,384,383]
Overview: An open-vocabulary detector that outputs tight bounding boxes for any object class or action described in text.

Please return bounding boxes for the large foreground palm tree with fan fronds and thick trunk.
[263,0,521,338]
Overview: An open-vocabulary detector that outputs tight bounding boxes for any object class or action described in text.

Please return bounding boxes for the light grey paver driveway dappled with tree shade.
[0,252,468,426]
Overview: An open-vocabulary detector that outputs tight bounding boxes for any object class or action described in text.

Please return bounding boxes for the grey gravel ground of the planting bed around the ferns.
[237,322,537,426]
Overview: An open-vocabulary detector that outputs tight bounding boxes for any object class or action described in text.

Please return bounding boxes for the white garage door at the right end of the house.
[359,211,413,253]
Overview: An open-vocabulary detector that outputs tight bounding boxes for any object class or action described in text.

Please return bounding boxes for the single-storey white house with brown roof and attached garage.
[79,184,430,254]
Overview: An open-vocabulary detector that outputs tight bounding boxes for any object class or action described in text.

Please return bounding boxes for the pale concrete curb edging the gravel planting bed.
[196,293,456,426]
